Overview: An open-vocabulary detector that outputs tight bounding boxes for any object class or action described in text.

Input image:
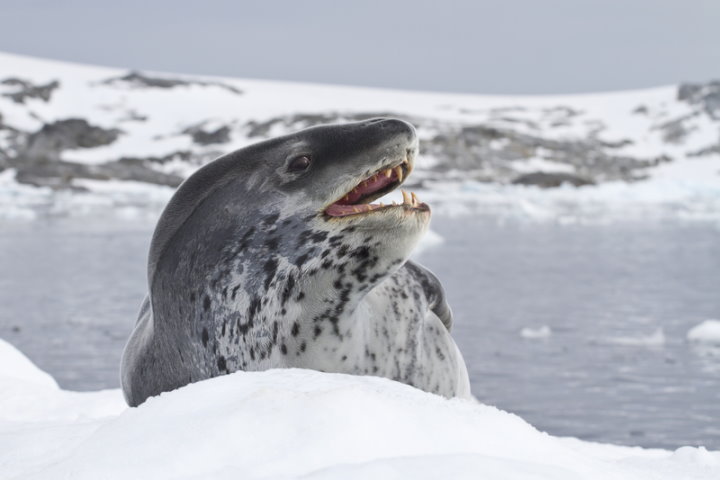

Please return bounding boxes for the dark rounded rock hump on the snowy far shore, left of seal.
[25,118,122,160]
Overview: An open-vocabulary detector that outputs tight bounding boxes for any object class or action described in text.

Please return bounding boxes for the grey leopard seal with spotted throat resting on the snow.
[121,118,470,406]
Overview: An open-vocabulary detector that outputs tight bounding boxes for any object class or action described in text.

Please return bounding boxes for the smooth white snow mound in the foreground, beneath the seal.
[0,342,720,480]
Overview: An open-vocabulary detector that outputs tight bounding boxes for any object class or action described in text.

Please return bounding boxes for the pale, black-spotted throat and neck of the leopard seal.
[151,215,414,373]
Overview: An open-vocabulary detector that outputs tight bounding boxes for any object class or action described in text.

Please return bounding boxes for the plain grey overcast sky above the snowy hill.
[0,0,720,93]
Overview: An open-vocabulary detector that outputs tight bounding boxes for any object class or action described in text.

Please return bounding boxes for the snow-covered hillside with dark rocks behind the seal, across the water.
[0,53,720,219]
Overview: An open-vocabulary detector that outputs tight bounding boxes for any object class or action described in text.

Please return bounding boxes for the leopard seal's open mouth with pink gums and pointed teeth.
[325,161,430,217]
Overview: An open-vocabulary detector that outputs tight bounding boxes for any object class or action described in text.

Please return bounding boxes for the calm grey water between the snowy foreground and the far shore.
[0,217,720,449]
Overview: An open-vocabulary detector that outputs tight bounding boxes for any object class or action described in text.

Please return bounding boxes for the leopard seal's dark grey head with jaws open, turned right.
[149,118,430,284]
